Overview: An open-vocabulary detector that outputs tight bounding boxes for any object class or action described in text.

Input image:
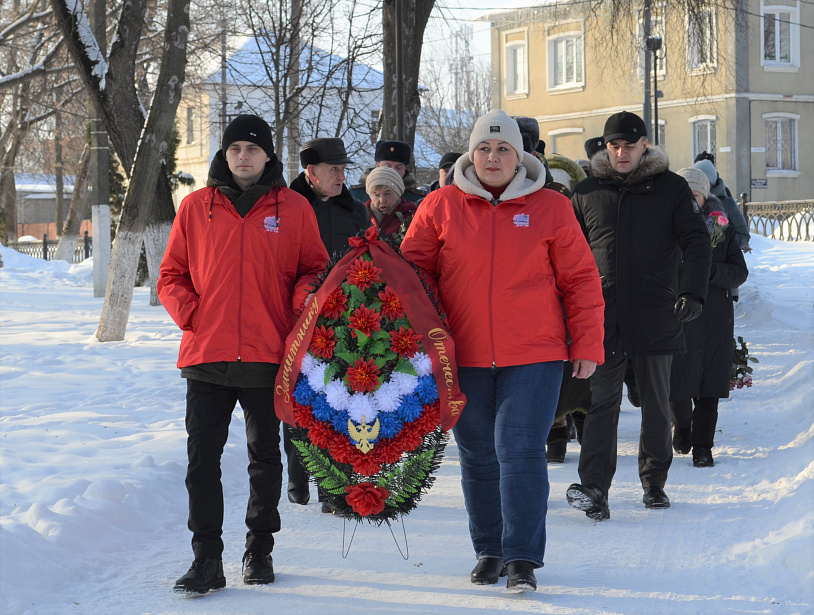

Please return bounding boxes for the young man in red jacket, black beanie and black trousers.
[158,115,328,594]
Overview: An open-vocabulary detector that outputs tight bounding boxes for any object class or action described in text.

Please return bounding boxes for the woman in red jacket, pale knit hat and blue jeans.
[401,110,604,590]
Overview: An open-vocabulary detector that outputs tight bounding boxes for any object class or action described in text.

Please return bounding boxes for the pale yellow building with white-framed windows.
[487,0,814,201]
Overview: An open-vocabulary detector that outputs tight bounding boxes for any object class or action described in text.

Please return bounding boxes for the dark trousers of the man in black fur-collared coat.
[579,355,673,495]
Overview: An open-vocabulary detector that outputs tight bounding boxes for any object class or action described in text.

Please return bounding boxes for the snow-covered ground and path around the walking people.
[0,237,814,615]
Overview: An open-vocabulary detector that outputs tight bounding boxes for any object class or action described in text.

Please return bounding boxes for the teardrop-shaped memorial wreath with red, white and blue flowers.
[275,228,465,522]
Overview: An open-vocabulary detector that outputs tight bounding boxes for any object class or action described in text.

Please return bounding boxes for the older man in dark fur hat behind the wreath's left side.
[283,138,373,513]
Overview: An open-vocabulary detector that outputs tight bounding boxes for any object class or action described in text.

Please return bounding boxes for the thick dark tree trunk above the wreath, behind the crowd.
[382,0,435,159]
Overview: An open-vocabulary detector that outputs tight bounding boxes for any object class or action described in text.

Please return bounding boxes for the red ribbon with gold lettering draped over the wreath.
[274,227,466,431]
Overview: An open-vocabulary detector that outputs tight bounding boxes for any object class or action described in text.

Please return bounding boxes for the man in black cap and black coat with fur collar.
[567,111,711,520]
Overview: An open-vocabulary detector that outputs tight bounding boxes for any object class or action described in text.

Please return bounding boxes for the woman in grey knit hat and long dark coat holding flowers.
[670,169,749,468]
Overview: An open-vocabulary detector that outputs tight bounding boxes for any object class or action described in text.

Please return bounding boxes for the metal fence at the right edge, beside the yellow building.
[740,193,814,241]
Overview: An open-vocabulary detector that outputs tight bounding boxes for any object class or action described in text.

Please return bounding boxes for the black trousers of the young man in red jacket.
[186,379,283,559]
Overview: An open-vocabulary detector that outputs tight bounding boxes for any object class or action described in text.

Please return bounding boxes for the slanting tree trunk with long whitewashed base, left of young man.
[96,0,189,342]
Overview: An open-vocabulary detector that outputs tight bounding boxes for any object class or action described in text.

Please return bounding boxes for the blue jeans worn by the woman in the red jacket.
[453,361,562,567]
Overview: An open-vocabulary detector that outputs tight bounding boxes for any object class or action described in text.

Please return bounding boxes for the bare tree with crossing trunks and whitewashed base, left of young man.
[51,0,189,341]
